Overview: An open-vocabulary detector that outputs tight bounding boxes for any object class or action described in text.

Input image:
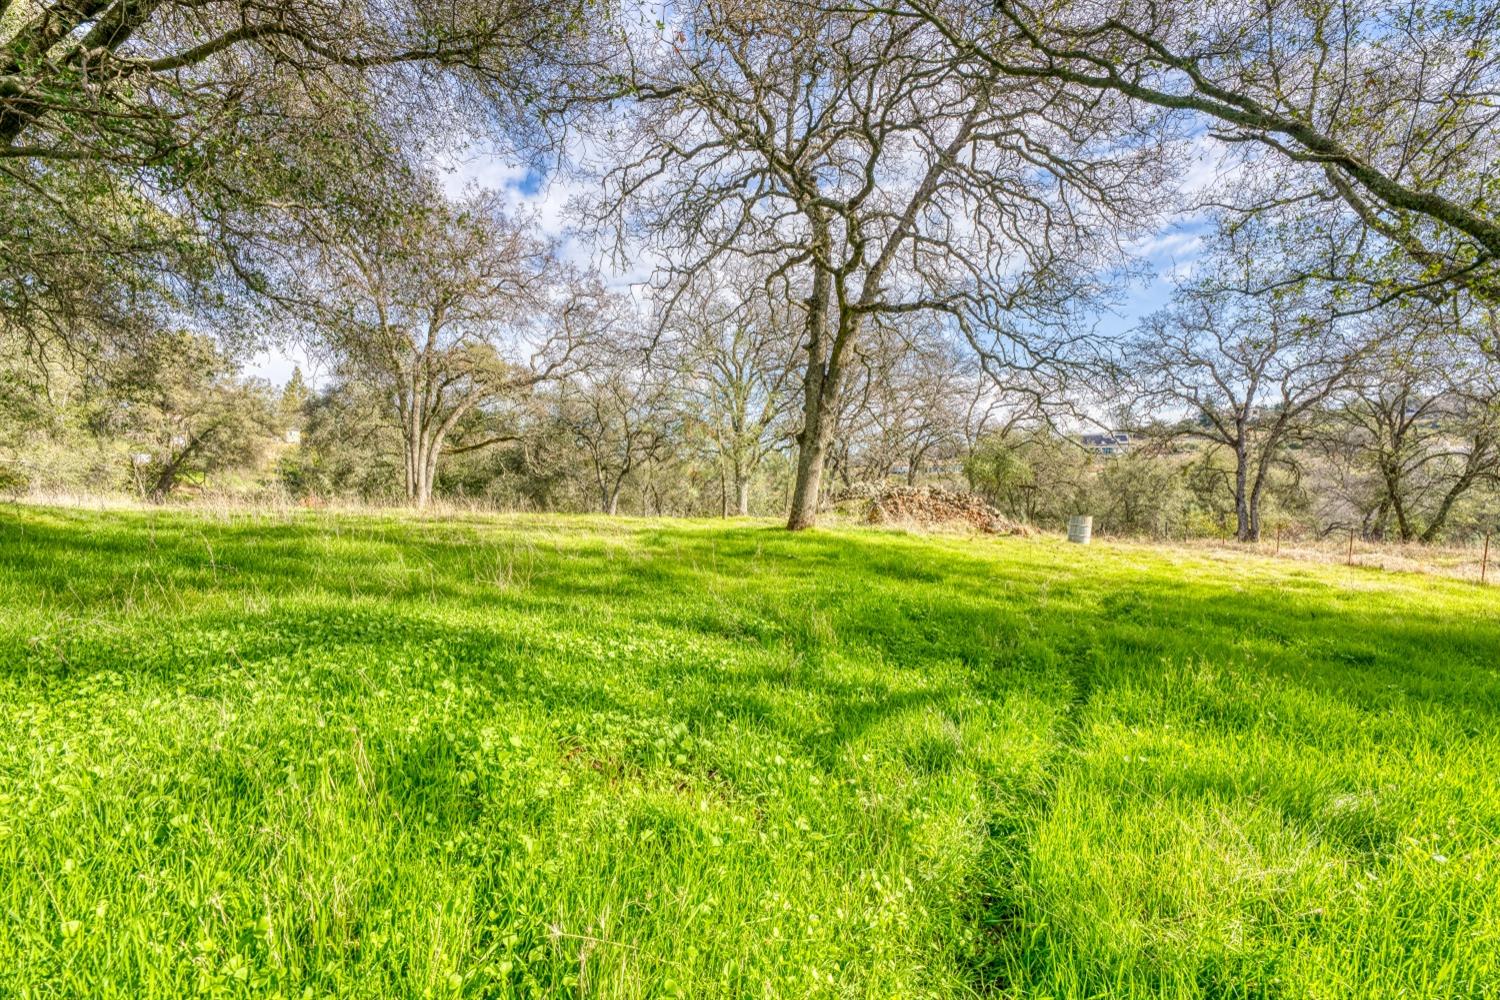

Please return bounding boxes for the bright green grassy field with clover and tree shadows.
[0,507,1500,999]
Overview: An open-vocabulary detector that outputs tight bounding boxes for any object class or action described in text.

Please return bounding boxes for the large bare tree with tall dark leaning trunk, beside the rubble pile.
[585,0,1164,529]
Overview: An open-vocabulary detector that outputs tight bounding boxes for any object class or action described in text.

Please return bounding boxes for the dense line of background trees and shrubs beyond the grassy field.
[5,305,1500,541]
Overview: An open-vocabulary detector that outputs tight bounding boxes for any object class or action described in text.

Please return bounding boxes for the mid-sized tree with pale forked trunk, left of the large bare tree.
[286,178,614,508]
